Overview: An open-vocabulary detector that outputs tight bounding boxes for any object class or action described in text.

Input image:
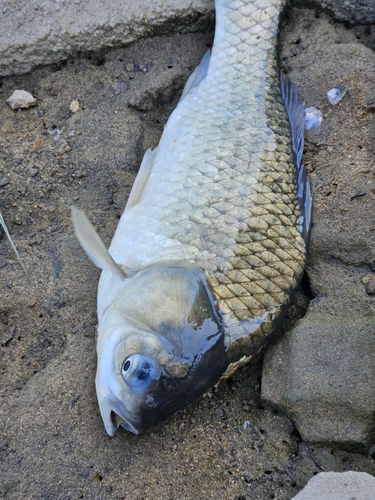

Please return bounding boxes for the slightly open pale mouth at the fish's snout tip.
[100,392,139,436]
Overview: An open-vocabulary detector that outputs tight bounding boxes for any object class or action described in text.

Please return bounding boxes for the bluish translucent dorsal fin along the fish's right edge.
[280,73,312,245]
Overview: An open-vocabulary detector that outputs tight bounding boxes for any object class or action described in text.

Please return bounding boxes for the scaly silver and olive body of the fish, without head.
[99,0,306,361]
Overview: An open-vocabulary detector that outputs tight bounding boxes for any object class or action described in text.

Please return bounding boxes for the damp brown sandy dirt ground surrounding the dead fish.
[0,3,375,500]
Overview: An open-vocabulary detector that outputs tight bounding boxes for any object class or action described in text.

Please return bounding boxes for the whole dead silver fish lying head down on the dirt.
[72,0,311,436]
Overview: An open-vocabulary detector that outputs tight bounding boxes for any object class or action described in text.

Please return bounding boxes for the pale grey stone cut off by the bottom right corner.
[292,471,375,500]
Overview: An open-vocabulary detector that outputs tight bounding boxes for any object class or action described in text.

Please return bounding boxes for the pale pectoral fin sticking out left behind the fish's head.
[70,205,126,279]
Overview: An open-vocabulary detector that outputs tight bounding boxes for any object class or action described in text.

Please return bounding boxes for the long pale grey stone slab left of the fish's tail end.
[0,0,213,76]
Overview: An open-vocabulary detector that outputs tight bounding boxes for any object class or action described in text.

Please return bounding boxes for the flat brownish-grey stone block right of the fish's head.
[262,308,375,451]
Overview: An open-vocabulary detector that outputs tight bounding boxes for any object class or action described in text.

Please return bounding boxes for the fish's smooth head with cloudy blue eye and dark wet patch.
[96,266,228,436]
